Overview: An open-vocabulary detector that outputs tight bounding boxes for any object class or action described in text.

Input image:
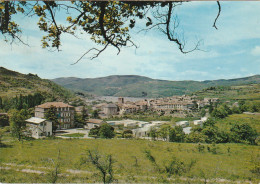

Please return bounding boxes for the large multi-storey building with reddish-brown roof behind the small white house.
[35,102,75,128]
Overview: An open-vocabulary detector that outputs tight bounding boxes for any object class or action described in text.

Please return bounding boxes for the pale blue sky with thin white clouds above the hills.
[0,1,260,81]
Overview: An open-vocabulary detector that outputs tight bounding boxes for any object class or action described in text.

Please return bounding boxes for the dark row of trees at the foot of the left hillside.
[0,93,45,112]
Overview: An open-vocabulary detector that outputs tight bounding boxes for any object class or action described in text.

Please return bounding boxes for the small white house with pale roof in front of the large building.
[25,117,52,139]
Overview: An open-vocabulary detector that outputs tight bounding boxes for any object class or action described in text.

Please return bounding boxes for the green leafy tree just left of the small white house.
[8,109,29,141]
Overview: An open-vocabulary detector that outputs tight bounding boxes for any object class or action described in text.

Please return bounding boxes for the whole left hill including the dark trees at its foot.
[0,67,75,103]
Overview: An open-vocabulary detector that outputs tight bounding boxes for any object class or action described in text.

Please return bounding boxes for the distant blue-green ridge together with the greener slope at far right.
[53,75,260,99]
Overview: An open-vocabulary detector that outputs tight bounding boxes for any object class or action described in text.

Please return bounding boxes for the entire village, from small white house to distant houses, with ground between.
[22,95,219,139]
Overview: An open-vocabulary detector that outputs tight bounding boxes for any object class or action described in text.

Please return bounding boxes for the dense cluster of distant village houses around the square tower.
[94,95,219,116]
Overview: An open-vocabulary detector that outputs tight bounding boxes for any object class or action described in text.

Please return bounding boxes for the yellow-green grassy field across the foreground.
[0,136,260,183]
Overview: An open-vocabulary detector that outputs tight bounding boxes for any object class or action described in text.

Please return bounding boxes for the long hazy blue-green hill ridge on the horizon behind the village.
[52,75,260,97]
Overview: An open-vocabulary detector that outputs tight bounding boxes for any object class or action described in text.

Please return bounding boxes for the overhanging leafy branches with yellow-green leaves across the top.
[0,1,221,63]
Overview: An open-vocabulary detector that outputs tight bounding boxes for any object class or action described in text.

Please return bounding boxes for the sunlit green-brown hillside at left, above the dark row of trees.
[0,67,74,100]
